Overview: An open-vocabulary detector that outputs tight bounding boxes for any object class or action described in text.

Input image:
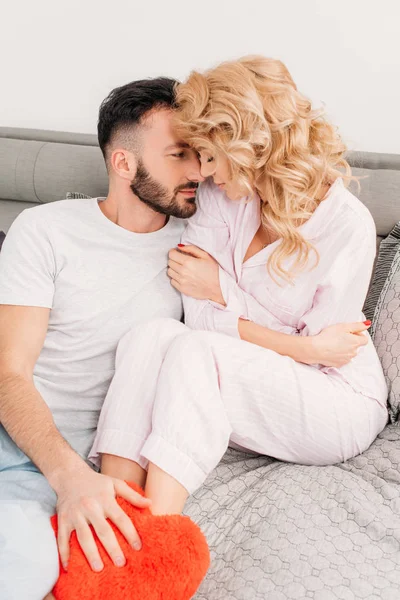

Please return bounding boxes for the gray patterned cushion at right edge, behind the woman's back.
[366,223,400,423]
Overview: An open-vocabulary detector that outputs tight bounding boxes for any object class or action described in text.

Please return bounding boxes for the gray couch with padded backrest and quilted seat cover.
[0,128,400,600]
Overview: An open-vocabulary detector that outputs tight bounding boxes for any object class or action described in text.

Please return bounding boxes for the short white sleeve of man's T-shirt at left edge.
[0,208,56,308]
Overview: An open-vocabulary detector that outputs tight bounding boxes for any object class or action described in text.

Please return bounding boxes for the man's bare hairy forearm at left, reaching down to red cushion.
[0,373,87,491]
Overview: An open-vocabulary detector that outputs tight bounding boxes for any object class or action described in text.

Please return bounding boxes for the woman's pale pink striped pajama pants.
[89,319,387,493]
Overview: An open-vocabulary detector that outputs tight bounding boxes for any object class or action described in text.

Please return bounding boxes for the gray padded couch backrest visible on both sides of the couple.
[0,127,400,237]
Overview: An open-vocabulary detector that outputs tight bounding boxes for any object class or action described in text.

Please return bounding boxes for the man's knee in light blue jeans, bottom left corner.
[0,502,59,600]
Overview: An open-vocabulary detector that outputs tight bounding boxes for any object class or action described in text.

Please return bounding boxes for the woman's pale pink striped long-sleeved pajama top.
[182,178,387,406]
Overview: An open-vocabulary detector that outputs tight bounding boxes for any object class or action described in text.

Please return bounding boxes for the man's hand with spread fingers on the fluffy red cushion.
[54,465,151,571]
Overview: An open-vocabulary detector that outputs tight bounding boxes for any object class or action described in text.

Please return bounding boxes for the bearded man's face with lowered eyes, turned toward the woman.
[131,109,203,219]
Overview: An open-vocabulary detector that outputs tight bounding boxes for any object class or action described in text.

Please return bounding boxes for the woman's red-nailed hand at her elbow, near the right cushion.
[307,321,371,368]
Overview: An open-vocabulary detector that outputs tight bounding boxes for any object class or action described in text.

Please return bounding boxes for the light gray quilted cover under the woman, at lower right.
[185,423,400,600]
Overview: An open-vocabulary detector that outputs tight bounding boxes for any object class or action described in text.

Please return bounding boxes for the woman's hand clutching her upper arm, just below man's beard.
[167,245,226,306]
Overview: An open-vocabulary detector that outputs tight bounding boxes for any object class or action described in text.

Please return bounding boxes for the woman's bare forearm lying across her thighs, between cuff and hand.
[238,319,315,364]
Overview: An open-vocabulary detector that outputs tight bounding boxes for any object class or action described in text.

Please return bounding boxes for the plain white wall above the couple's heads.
[0,0,400,153]
